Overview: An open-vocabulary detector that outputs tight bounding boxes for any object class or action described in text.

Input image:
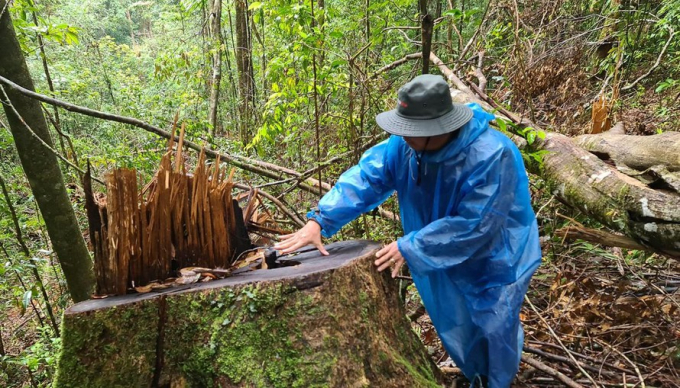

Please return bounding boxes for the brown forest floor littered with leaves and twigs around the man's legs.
[407,241,680,387]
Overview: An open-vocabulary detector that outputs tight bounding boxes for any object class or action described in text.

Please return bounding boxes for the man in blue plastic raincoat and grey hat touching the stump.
[275,75,541,388]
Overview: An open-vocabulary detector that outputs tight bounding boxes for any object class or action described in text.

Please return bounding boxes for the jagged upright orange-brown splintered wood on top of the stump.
[84,148,238,295]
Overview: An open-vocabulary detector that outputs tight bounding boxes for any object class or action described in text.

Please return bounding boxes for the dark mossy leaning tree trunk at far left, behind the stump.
[0,0,94,302]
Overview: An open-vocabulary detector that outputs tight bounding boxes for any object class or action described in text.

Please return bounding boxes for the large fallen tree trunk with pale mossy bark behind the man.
[430,54,680,256]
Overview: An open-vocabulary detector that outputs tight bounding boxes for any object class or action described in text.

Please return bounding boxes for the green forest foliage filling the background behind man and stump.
[0,0,680,387]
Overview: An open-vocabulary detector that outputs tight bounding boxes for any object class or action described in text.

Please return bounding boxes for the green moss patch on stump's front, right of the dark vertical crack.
[166,285,334,387]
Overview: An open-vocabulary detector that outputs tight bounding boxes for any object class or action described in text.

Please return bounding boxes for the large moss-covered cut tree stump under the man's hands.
[56,241,439,388]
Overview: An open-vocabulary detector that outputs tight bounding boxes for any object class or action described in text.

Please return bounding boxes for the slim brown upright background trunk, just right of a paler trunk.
[235,0,255,144]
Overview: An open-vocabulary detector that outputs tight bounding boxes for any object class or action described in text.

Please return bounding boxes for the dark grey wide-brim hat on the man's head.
[375,74,472,137]
